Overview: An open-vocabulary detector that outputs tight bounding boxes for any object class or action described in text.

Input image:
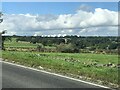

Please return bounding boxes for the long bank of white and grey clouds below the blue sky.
[0,8,118,36]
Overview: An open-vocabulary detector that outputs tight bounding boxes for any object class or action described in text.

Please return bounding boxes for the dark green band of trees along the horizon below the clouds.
[4,36,120,53]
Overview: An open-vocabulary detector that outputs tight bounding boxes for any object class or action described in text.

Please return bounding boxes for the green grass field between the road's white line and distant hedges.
[2,51,118,87]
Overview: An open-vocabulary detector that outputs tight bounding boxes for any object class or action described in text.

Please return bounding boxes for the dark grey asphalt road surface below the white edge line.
[2,63,109,88]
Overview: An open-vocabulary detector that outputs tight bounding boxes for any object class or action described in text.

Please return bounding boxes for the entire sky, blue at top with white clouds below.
[0,2,118,36]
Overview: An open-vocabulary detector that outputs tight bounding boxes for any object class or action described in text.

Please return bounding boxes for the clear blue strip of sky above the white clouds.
[2,2,118,14]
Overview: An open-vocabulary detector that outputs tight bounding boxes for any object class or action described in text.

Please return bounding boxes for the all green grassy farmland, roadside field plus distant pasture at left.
[2,35,120,87]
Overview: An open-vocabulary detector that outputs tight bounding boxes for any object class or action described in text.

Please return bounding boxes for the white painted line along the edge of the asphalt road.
[0,61,110,89]
